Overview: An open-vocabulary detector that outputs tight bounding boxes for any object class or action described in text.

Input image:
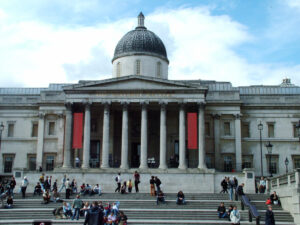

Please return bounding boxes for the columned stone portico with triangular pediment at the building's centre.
[63,76,207,170]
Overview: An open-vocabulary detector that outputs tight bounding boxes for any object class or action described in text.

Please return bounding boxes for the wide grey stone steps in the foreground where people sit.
[0,193,294,225]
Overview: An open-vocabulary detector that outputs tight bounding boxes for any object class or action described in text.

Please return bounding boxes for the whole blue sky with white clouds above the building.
[0,0,300,87]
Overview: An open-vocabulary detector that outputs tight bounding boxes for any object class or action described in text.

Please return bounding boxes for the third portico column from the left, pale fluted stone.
[101,103,110,168]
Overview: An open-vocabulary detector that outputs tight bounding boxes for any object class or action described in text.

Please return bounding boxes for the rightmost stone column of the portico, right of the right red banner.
[198,102,206,169]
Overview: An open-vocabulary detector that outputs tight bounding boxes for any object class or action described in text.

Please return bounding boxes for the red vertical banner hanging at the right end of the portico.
[187,113,198,149]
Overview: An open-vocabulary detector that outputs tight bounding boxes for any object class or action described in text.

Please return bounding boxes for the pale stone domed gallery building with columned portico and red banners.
[0,14,300,179]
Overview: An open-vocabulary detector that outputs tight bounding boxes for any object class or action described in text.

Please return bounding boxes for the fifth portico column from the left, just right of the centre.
[140,102,148,169]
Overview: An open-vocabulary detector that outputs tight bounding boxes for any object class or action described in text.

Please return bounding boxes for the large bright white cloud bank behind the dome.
[0,5,300,87]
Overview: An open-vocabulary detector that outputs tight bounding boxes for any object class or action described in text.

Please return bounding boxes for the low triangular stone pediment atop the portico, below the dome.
[64,75,203,91]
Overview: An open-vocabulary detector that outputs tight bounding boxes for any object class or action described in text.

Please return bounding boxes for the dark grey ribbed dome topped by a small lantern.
[112,13,169,63]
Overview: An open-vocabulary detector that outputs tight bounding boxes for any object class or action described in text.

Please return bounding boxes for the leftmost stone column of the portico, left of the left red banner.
[63,104,73,168]
